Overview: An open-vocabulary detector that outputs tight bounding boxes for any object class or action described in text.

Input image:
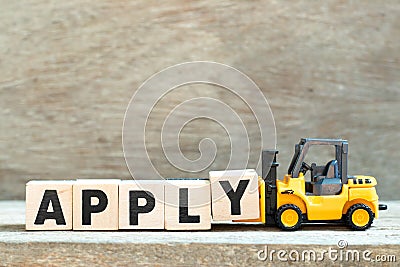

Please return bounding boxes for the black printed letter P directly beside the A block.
[82,190,108,225]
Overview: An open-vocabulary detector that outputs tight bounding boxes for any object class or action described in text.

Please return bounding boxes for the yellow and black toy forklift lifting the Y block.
[260,138,387,231]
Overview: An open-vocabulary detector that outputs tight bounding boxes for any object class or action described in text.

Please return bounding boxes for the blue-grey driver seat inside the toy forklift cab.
[312,160,342,196]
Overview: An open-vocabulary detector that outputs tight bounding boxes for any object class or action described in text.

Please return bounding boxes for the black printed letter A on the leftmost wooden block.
[35,190,66,225]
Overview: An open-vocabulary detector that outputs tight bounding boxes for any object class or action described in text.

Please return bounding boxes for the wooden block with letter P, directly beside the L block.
[119,180,164,229]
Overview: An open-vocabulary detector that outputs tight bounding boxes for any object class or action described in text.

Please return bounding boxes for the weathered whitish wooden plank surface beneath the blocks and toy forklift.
[0,201,400,266]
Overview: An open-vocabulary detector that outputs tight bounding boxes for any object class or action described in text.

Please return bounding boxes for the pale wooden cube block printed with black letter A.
[25,181,74,230]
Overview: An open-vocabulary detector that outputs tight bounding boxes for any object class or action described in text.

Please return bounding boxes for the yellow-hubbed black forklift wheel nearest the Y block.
[276,204,302,231]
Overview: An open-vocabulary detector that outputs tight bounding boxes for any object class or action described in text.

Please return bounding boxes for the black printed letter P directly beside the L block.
[129,190,156,225]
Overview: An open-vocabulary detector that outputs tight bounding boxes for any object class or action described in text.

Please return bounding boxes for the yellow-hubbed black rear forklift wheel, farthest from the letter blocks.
[346,203,374,231]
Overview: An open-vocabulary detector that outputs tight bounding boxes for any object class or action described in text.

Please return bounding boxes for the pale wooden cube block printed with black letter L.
[165,179,211,230]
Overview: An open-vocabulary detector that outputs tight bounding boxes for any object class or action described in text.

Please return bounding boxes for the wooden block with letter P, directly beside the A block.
[73,179,120,230]
